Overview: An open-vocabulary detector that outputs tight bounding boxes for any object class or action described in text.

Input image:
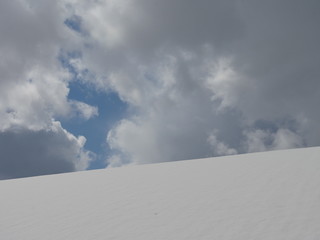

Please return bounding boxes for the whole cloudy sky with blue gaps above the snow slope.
[0,0,320,179]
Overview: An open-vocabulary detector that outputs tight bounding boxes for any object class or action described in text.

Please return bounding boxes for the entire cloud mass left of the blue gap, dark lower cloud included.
[0,0,97,179]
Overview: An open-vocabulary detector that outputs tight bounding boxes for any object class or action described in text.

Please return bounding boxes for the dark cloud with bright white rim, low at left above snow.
[0,122,94,179]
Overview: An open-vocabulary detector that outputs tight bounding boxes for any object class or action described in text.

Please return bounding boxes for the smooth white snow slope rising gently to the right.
[0,147,320,240]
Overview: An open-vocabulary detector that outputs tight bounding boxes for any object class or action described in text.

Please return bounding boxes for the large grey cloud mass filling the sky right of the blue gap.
[68,0,320,163]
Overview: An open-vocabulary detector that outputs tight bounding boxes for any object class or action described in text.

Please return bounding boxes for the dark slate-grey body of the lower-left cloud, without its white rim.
[0,131,75,178]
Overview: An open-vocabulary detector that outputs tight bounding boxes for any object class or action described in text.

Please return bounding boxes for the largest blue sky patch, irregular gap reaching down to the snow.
[59,52,128,169]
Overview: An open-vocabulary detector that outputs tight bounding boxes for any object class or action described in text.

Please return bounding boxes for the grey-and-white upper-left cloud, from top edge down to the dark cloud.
[0,0,95,131]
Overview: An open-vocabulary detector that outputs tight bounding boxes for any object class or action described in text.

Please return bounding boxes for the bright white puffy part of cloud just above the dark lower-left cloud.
[0,66,69,131]
